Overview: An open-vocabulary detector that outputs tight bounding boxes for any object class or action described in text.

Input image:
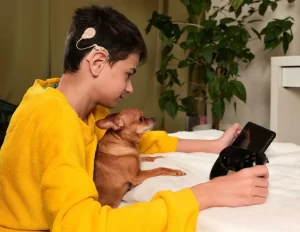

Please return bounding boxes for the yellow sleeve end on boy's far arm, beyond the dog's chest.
[140,131,178,154]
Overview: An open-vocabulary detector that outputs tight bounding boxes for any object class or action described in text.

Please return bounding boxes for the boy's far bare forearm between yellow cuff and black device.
[176,139,221,153]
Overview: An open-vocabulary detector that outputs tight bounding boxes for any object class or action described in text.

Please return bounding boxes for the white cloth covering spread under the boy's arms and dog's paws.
[123,130,300,232]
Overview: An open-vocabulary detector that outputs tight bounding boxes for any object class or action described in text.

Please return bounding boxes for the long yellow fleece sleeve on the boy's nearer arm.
[41,119,199,232]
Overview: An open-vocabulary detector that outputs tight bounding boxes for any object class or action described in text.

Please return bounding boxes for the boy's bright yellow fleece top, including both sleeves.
[0,78,199,232]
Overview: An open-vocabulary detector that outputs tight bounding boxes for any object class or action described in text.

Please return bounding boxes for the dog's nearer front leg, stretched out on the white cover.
[131,168,185,186]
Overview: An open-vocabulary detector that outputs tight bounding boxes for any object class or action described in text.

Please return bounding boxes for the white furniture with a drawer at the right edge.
[270,56,300,145]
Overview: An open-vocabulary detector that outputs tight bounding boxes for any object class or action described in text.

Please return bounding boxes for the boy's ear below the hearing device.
[86,50,108,77]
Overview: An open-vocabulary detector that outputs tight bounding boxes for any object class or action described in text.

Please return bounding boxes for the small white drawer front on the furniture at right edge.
[282,67,300,88]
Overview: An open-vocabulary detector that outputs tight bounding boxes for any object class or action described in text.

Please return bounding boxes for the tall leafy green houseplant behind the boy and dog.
[145,0,295,129]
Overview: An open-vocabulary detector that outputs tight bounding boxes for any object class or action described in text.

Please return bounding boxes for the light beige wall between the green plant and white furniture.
[206,0,300,128]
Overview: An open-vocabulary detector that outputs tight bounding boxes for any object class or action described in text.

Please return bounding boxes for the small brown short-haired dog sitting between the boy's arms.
[94,109,185,208]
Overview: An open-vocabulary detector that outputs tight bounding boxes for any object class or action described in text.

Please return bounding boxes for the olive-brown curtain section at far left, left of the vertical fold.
[0,0,50,104]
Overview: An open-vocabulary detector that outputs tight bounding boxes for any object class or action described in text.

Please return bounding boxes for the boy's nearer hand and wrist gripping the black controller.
[192,165,269,210]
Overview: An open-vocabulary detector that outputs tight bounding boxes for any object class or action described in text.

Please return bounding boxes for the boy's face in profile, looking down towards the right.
[91,54,139,108]
